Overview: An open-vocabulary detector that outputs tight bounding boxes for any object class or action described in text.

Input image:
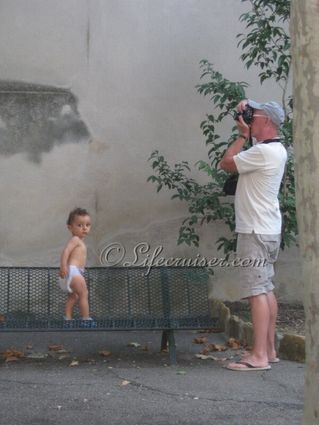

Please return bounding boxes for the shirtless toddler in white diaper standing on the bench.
[59,208,92,320]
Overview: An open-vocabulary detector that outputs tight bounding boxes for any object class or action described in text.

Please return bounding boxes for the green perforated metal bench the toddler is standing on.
[0,267,218,364]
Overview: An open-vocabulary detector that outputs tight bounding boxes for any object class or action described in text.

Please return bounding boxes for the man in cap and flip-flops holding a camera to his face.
[219,99,287,371]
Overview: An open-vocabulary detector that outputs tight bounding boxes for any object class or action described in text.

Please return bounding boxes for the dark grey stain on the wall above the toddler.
[0,80,90,162]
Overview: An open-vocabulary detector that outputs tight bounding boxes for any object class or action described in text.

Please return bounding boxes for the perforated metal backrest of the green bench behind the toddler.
[0,267,209,318]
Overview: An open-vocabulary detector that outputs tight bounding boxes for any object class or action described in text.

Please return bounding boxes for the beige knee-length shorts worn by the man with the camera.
[236,233,281,298]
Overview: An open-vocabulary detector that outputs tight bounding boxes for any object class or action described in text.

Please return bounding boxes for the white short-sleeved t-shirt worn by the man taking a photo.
[234,142,287,235]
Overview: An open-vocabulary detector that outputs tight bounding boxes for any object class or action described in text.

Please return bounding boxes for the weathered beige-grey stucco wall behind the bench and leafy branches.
[0,0,302,299]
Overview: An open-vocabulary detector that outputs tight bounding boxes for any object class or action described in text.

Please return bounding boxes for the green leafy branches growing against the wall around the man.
[148,0,297,254]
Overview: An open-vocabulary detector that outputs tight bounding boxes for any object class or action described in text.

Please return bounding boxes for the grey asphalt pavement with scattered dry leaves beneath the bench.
[0,331,304,425]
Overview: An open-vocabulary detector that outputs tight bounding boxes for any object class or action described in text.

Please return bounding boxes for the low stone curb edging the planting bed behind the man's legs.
[211,300,305,363]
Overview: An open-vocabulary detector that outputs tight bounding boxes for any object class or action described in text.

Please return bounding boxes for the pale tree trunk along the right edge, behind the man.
[290,0,319,425]
